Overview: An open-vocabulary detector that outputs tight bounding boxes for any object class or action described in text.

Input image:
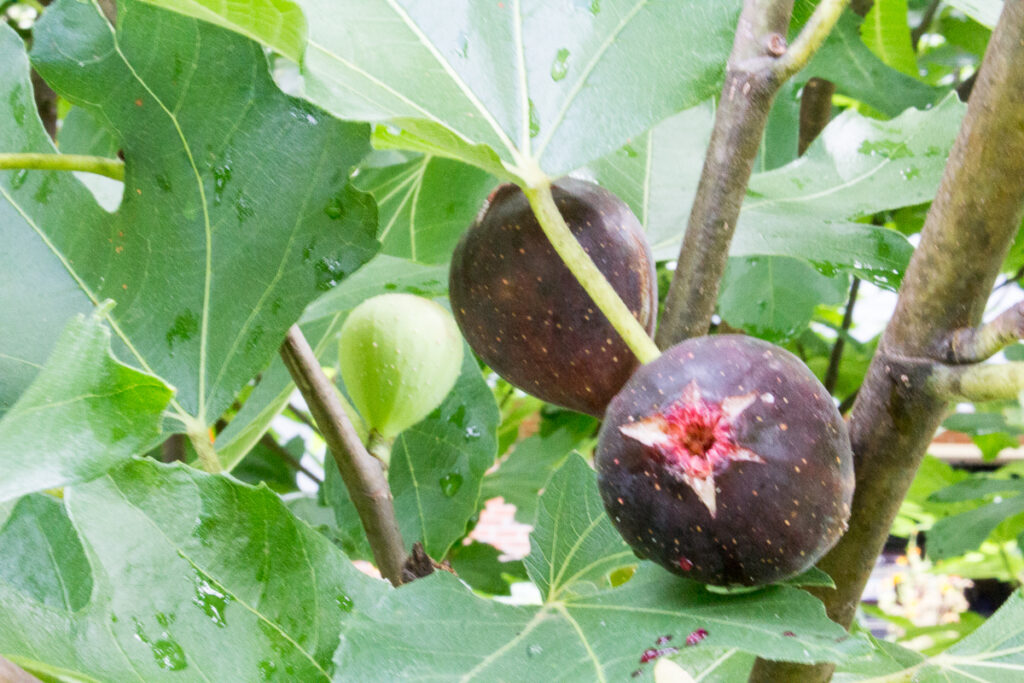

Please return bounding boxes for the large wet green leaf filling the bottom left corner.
[0,460,387,681]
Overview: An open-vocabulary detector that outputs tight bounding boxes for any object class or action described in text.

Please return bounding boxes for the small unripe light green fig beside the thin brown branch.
[338,294,462,440]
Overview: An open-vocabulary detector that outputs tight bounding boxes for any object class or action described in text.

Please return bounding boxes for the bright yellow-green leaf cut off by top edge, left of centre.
[142,0,306,61]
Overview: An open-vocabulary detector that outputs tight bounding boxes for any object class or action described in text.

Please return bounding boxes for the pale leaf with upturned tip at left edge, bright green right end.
[0,312,172,501]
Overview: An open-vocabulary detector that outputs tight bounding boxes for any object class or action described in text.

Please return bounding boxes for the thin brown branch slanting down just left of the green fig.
[281,325,406,586]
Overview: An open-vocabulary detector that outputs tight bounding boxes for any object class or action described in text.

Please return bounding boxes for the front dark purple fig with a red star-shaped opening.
[595,335,853,586]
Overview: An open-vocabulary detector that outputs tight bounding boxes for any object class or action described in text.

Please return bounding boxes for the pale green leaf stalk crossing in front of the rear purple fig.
[522,177,662,365]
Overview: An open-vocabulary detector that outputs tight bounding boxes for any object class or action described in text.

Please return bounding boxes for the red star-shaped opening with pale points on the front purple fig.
[618,380,764,517]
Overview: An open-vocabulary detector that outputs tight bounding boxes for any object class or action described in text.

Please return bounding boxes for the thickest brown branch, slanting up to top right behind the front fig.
[755,2,1024,681]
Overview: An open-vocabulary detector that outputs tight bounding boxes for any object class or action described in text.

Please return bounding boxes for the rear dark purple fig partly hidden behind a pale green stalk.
[449,178,657,417]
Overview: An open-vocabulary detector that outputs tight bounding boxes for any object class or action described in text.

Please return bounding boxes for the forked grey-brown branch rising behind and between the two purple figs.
[657,0,847,348]
